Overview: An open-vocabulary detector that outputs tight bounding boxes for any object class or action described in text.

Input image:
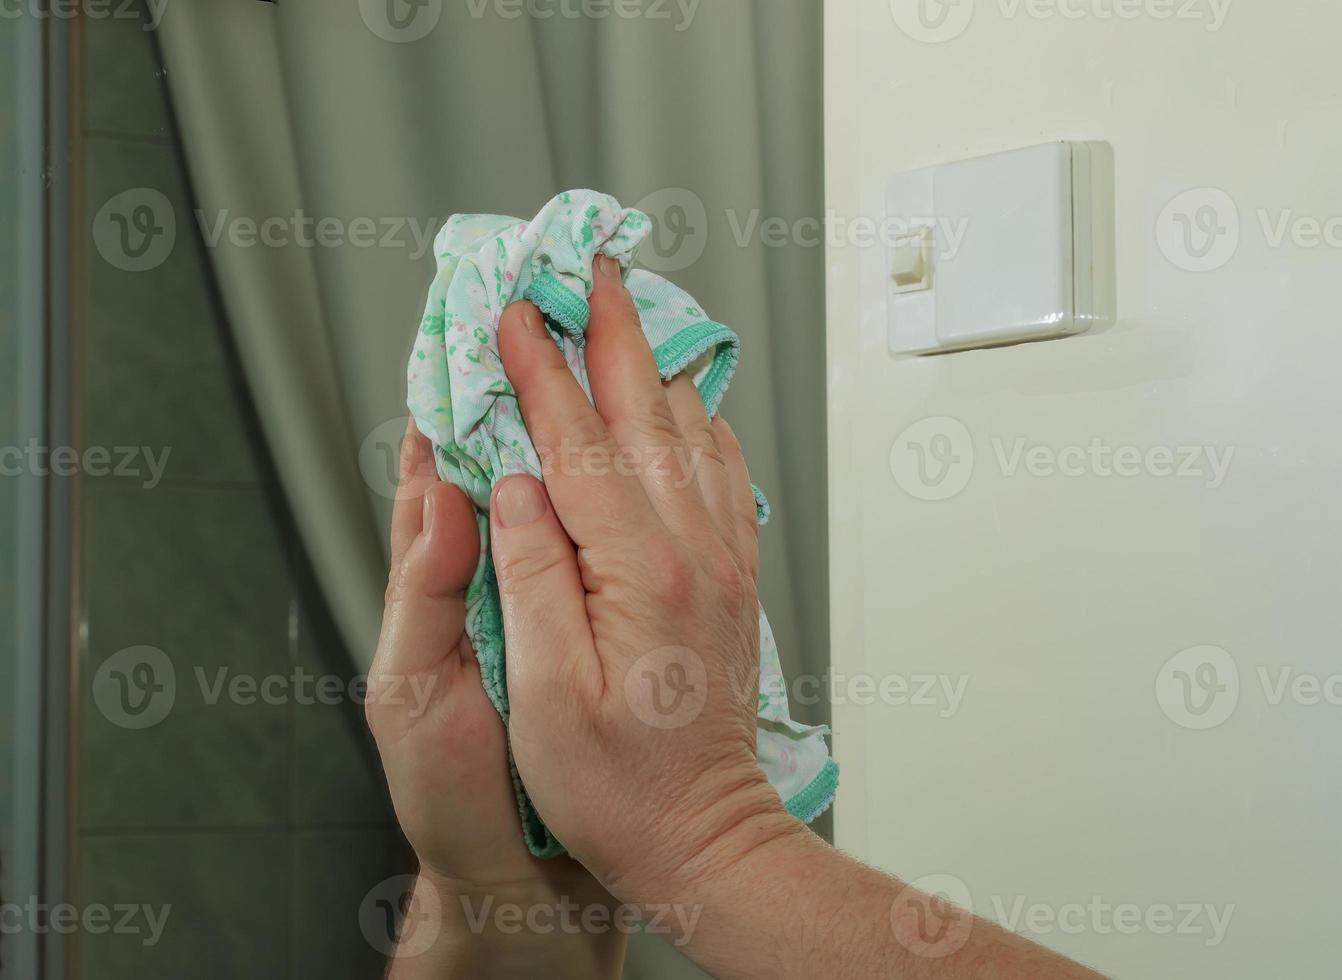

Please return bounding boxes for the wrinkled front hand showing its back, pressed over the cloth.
[491,259,801,903]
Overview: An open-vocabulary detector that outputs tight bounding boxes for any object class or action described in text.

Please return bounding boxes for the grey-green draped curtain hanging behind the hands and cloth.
[160,0,829,976]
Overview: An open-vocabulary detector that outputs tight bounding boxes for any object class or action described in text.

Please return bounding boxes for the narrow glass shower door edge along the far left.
[0,7,66,980]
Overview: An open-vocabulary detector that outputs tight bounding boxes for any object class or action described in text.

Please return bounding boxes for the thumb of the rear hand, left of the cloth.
[369,482,480,679]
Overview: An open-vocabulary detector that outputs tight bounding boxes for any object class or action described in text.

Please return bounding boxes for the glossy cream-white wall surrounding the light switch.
[825,0,1342,980]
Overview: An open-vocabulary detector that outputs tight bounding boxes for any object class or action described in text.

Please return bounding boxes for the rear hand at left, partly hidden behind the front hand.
[366,423,623,977]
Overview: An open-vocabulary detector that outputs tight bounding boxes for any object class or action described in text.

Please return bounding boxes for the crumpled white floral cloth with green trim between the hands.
[407,191,839,858]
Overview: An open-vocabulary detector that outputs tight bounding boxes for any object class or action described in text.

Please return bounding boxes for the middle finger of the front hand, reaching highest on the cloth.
[586,255,707,533]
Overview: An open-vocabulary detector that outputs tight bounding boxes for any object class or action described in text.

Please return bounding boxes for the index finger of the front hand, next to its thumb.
[499,301,655,548]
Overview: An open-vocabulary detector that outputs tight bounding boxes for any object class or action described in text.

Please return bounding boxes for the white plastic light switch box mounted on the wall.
[886,142,1115,354]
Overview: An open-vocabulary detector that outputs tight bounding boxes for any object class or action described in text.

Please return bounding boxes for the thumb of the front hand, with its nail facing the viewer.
[490,475,601,705]
